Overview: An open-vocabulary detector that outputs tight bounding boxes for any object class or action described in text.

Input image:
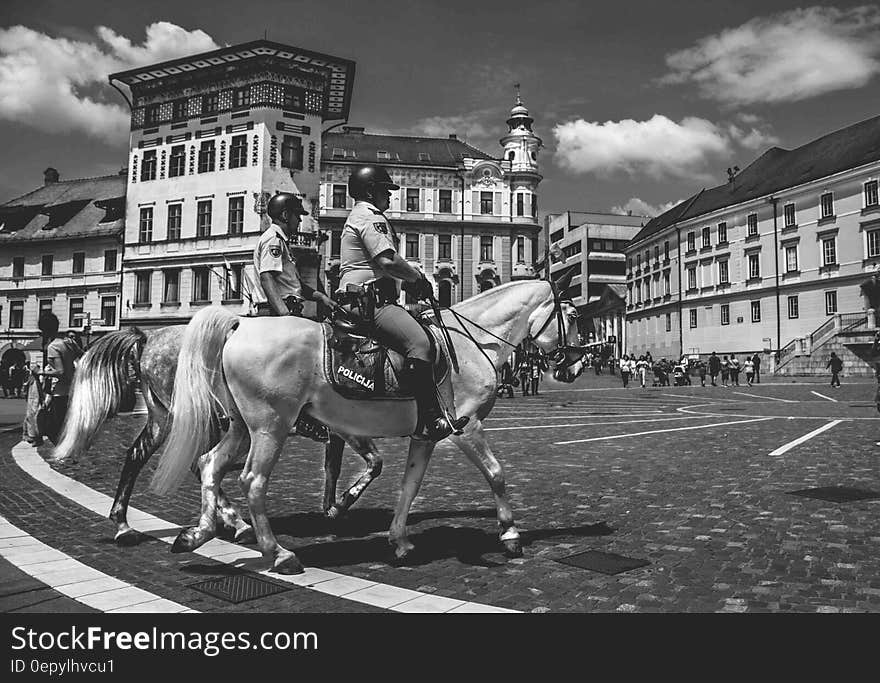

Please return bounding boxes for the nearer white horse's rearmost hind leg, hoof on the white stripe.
[171,420,247,553]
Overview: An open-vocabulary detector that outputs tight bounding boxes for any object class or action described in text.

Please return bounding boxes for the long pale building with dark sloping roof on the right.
[626,117,880,368]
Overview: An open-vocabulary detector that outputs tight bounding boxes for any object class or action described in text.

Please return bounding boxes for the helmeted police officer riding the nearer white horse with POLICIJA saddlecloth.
[337,165,468,441]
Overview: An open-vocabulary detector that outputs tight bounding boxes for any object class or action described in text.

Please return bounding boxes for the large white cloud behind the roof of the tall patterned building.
[0,21,218,143]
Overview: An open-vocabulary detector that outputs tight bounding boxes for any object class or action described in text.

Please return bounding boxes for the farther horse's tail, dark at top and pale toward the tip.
[52,327,147,461]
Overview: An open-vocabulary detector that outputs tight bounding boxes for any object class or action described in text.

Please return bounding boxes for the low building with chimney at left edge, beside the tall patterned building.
[0,168,126,360]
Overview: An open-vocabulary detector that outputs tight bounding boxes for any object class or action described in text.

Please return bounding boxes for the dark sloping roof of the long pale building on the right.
[632,116,880,243]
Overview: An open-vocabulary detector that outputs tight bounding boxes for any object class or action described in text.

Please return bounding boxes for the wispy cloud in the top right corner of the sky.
[660,5,880,105]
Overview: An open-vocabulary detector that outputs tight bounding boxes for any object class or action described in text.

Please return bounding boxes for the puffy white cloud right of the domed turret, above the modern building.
[553,114,731,178]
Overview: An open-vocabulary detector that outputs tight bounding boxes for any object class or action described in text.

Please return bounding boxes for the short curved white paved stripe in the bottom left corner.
[0,516,191,614]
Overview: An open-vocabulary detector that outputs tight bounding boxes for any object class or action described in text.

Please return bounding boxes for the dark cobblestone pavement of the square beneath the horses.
[0,375,880,612]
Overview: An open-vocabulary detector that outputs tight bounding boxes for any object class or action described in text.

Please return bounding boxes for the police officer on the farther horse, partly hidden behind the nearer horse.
[254,192,336,315]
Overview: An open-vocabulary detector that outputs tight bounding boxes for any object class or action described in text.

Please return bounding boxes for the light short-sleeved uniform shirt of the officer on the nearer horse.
[338,201,397,292]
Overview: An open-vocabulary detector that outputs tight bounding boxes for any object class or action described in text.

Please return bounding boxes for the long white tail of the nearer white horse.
[150,306,238,495]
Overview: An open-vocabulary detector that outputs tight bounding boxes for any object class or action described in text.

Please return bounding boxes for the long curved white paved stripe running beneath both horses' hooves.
[10,441,518,613]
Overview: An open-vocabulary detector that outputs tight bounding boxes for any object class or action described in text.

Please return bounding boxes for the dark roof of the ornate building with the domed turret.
[322,132,496,166]
